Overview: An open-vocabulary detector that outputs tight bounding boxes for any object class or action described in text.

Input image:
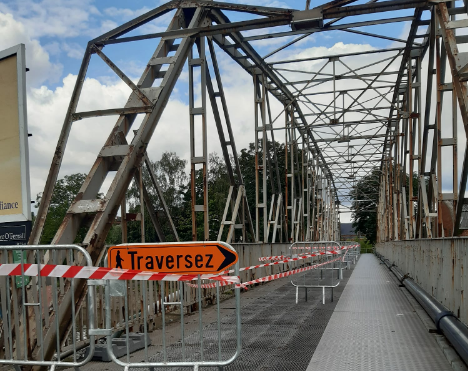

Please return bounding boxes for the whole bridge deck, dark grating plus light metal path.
[74,254,452,371]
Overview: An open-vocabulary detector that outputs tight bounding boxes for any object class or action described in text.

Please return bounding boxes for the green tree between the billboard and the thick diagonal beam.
[35,173,86,244]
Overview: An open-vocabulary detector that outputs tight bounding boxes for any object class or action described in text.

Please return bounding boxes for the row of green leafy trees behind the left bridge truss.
[36,142,301,244]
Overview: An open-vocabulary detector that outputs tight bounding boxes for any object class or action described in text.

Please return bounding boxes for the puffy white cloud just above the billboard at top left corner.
[0,13,62,86]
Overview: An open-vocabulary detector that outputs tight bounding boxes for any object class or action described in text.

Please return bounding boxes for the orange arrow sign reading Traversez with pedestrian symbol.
[107,242,238,274]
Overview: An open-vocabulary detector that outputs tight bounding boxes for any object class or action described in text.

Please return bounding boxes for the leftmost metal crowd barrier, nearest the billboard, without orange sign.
[0,245,95,371]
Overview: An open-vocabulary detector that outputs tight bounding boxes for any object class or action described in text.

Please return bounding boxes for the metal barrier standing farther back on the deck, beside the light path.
[290,241,344,304]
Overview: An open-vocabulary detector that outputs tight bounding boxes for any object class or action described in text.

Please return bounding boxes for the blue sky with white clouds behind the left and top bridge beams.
[0,0,424,221]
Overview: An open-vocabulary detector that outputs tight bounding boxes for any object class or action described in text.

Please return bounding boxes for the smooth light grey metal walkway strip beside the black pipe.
[307,254,452,371]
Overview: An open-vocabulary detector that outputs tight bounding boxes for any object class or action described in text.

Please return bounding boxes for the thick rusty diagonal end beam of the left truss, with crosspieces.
[35,9,205,359]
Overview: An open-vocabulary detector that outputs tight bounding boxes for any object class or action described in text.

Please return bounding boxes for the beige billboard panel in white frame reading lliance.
[0,44,31,223]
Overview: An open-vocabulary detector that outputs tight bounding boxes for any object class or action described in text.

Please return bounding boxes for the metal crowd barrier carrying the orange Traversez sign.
[93,242,242,371]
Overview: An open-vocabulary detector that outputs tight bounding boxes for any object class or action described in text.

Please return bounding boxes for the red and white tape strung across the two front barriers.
[0,263,239,284]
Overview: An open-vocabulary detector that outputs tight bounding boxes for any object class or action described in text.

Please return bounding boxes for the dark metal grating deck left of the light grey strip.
[139,270,352,371]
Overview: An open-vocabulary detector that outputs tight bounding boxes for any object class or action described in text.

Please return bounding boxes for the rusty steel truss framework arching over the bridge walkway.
[9,0,468,370]
